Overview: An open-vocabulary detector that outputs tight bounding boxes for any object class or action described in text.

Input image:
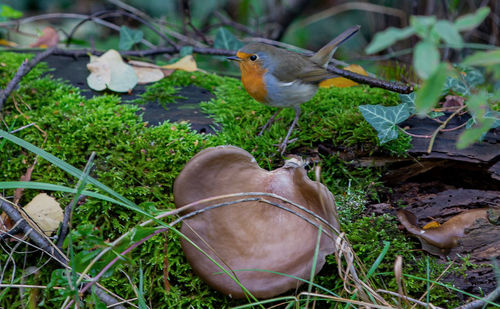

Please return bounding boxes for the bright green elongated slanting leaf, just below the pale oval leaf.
[415,64,447,115]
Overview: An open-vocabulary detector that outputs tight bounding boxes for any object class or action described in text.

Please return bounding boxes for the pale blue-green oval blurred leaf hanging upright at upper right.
[413,40,440,79]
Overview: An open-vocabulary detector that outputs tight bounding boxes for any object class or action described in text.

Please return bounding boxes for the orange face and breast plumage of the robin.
[240,56,267,103]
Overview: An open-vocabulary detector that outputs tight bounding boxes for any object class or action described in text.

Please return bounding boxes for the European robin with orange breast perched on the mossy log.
[227,26,360,154]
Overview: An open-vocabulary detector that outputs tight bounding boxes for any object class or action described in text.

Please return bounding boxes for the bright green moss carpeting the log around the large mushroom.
[0,52,460,308]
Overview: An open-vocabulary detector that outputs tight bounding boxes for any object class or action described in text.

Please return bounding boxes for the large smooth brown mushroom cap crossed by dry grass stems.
[174,146,339,298]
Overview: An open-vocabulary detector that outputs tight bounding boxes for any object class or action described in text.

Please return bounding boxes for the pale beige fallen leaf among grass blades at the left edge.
[23,193,64,236]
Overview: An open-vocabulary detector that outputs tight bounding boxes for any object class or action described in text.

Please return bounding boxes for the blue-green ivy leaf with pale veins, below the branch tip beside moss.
[359,104,410,144]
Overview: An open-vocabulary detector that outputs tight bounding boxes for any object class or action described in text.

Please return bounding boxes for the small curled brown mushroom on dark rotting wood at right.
[397,208,488,255]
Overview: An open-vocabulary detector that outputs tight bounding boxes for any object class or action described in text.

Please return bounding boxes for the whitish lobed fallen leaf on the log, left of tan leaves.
[87,49,138,92]
